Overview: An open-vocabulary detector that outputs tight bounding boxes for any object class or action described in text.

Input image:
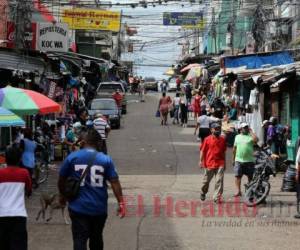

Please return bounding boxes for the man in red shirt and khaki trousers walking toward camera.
[199,123,226,203]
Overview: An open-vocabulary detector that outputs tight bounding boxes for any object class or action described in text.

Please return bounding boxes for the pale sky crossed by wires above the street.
[112,0,205,79]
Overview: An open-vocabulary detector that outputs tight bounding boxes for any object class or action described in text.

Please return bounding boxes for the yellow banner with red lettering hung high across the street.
[62,8,121,32]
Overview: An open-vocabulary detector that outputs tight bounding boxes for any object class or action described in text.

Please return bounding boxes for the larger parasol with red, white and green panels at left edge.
[0,86,61,115]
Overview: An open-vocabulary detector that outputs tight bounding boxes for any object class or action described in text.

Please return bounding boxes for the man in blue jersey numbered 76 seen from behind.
[58,129,125,250]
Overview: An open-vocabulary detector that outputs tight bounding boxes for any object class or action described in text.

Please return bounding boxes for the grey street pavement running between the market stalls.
[26,93,300,250]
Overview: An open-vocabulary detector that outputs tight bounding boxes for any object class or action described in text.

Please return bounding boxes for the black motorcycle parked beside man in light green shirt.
[244,148,276,207]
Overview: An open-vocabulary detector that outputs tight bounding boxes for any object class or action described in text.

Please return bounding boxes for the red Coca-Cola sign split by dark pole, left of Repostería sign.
[6,22,37,50]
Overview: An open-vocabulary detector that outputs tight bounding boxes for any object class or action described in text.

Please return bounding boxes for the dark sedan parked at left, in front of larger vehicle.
[89,98,121,129]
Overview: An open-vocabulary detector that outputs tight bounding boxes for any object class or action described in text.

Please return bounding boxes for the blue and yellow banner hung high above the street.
[163,12,205,28]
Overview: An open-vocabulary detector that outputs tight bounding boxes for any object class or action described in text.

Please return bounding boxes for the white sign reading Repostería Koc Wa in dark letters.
[36,23,69,52]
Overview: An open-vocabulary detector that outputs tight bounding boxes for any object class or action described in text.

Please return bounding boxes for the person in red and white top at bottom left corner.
[0,147,32,250]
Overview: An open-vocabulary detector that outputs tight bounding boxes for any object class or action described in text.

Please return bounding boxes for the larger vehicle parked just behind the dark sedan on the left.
[97,82,127,114]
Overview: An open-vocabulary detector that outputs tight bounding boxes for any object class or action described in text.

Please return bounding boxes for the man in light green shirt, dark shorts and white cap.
[233,122,258,197]
